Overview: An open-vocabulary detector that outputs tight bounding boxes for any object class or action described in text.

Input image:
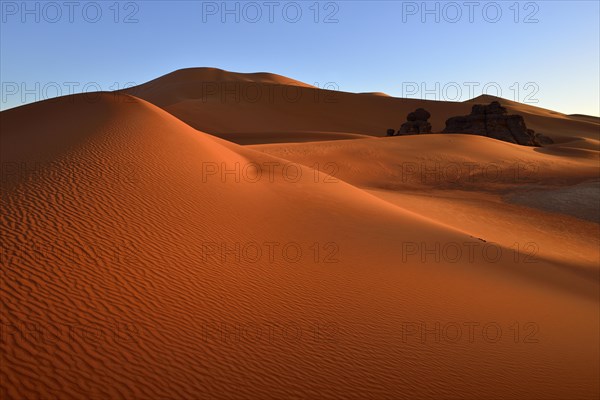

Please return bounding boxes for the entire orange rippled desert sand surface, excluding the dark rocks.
[0,68,600,399]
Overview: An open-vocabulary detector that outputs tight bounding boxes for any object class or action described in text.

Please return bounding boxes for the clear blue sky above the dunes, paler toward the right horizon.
[0,0,600,115]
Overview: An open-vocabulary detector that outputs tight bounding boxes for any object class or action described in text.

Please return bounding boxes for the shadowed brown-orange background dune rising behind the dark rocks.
[126,68,600,148]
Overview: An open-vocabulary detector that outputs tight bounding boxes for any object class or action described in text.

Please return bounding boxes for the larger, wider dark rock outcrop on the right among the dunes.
[443,101,554,146]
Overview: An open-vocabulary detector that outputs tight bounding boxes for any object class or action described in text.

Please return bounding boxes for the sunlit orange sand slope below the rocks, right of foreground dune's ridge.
[252,135,600,288]
